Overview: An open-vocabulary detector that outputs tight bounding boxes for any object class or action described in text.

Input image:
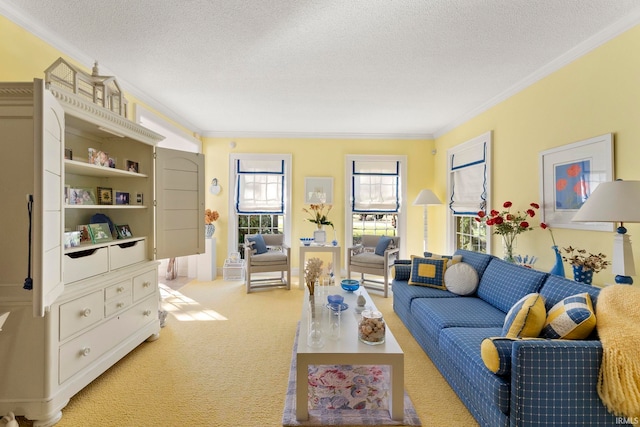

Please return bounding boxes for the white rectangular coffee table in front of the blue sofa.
[296,286,404,421]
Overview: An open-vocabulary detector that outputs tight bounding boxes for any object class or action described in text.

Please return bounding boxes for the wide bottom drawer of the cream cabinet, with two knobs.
[58,298,158,384]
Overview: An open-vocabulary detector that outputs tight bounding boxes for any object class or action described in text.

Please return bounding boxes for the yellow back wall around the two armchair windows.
[203,138,434,266]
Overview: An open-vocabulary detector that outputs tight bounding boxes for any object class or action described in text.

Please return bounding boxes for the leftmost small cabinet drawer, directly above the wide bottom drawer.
[60,291,104,340]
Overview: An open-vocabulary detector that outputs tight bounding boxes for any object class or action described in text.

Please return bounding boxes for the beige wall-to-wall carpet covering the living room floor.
[13,279,477,427]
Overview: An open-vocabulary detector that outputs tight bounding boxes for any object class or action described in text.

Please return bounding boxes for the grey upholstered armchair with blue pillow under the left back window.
[244,234,291,293]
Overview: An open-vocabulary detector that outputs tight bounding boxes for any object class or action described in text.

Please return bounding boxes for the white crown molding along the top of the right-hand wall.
[434,11,640,138]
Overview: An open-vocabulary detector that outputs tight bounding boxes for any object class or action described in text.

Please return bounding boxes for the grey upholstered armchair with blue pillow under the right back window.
[347,235,400,298]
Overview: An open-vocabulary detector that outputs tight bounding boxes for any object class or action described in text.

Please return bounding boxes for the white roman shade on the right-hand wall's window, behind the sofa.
[449,141,487,215]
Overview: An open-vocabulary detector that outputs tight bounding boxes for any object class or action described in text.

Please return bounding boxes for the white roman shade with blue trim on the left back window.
[236,159,284,214]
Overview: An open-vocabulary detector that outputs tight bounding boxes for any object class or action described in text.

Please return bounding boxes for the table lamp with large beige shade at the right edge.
[572,180,640,285]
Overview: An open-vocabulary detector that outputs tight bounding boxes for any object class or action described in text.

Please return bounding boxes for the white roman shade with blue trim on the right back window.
[352,160,400,213]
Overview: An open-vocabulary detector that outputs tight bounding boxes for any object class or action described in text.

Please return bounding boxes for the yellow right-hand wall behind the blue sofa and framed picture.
[430,26,640,284]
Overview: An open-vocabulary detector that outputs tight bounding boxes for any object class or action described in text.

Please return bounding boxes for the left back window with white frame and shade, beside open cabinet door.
[229,154,291,257]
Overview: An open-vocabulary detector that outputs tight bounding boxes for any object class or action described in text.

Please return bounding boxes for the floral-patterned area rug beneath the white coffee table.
[282,324,422,427]
